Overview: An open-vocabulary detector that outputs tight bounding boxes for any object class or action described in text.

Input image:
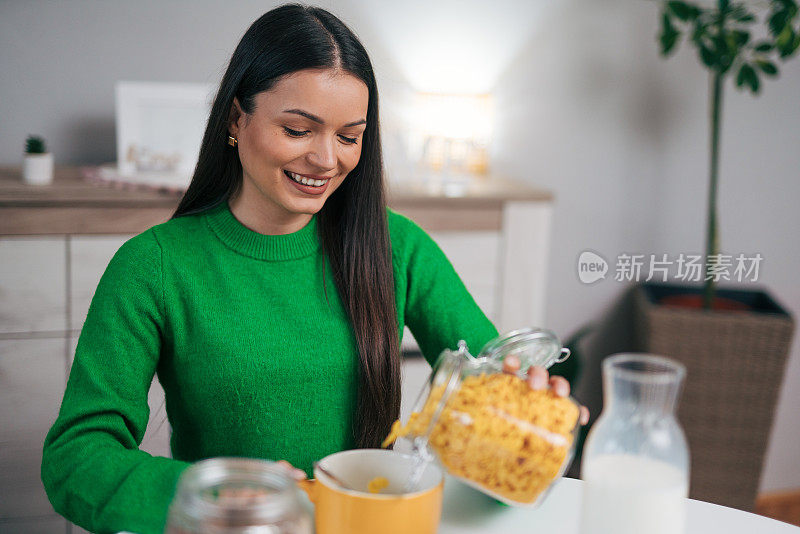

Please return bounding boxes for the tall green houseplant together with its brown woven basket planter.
[628,0,800,510]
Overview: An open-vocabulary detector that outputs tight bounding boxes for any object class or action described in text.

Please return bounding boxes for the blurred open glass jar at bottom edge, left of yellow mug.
[166,458,313,534]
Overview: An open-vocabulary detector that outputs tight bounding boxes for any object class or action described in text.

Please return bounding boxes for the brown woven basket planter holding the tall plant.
[632,284,794,511]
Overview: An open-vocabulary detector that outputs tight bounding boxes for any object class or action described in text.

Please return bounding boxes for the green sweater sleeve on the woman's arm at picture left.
[41,229,189,534]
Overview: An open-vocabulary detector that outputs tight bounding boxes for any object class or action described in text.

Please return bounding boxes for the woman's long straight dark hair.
[172,4,400,447]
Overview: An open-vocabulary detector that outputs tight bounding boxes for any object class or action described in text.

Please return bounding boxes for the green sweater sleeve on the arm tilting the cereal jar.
[389,210,497,365]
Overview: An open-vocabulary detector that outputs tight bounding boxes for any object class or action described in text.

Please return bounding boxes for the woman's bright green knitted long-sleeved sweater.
[42,202,497,534]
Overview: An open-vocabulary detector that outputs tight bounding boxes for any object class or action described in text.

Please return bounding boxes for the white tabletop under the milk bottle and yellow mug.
[439,477,800,534]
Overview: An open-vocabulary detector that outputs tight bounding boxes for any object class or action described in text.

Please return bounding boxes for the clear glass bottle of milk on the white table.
[581,354,689,534]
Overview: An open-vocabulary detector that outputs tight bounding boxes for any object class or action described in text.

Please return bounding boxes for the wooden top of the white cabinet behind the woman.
[0,167,552,235]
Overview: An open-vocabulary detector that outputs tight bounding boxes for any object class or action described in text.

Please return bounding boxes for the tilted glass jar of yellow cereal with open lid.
[387,328,579,506]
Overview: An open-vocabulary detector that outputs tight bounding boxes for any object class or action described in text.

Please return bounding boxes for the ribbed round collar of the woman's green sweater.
[205,200,319,261]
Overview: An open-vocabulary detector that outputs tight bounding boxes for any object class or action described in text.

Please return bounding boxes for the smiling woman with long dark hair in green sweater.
[42,5,588,534]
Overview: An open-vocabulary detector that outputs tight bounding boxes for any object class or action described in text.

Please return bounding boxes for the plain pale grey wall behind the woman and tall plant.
[0,0,800,490]
